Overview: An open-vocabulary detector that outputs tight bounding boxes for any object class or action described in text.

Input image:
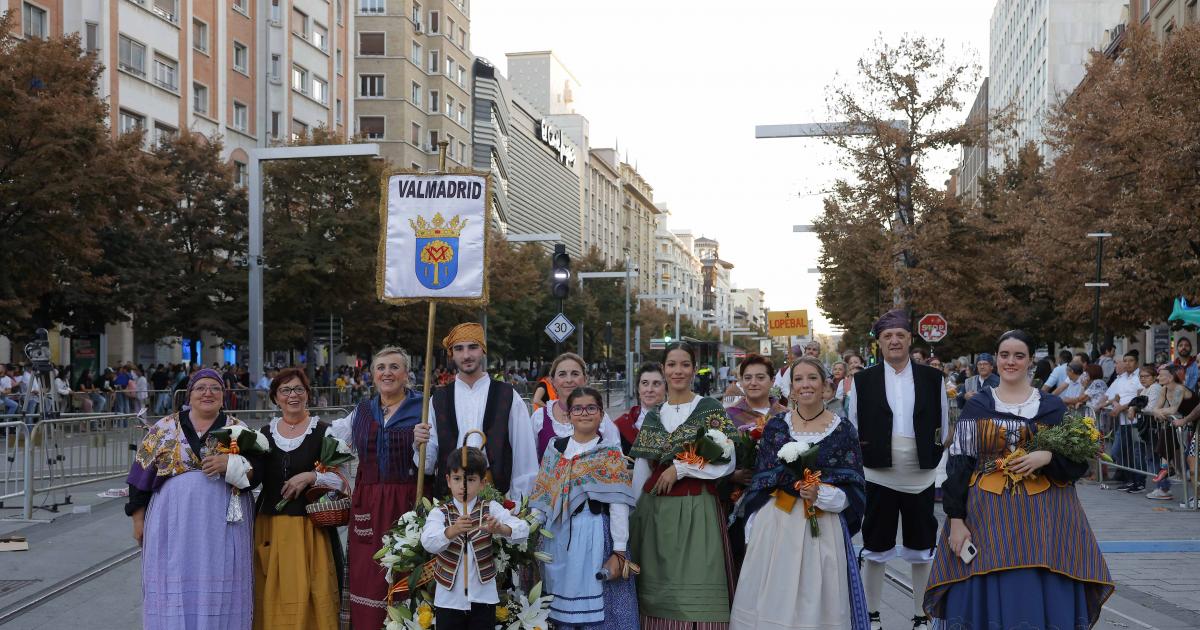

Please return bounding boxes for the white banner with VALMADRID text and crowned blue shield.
[377,172,491,306]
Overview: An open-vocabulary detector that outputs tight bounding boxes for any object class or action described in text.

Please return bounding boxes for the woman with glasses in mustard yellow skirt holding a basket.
[254,367,344,630]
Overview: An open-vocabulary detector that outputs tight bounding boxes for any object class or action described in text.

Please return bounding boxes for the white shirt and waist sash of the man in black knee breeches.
[846,361,950,493]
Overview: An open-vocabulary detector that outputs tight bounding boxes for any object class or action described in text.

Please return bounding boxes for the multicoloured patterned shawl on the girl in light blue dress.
[529,438,637,522]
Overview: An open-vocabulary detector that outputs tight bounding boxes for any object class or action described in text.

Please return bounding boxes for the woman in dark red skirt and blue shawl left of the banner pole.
[330,347,421,628]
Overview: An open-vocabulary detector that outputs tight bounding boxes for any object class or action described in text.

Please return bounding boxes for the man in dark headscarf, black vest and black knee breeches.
[847,310,949,630]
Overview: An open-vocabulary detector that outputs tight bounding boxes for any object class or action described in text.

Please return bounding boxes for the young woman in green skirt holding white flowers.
[629,342,737,630]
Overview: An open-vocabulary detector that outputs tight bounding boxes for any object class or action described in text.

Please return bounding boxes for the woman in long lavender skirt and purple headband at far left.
[125,368,262,630]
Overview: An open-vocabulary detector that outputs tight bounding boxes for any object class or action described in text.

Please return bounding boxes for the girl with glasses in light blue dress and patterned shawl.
[529,386,638,630]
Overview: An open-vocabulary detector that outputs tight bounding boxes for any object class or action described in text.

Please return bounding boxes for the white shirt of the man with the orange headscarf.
[413,374,537,500]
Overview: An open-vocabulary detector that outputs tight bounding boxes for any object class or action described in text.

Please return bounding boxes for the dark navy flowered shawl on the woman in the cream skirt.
[733,413,866,536]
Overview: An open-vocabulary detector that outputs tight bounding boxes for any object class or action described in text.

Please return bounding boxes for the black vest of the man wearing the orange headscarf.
[430,376,516,497]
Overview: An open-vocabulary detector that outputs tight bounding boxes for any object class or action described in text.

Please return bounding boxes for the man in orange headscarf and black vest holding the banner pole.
[413,323,538,500]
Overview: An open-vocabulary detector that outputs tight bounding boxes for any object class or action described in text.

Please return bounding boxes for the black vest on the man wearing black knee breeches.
[854,362,943,470]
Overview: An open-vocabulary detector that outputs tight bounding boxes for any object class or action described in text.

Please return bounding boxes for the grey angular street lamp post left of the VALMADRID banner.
[246,143,379,383]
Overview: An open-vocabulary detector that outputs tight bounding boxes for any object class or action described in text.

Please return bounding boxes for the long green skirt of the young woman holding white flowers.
[629,492,731,623]
